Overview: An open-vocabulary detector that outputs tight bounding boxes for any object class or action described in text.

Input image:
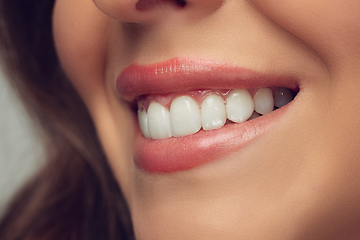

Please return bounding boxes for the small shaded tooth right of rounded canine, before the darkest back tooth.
[253,88,274,114]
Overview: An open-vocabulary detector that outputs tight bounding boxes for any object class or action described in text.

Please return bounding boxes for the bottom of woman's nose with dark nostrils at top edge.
[93,0,224,23]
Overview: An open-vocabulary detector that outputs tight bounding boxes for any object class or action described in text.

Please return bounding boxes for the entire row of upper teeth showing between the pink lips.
[138,87,293,139]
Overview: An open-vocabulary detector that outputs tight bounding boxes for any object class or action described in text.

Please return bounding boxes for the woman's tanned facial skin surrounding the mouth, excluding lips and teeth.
[53,0,360,240]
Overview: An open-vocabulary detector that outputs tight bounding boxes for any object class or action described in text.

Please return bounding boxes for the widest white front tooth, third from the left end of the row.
[170,96,201,137]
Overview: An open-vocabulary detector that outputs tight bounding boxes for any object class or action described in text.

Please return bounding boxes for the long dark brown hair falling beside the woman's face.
[0,0,133,240]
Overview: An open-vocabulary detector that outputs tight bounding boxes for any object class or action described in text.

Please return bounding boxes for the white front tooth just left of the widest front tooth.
[148,102,172,139]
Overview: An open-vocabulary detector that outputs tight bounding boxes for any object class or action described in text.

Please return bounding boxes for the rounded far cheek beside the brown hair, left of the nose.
[53,0,108,108]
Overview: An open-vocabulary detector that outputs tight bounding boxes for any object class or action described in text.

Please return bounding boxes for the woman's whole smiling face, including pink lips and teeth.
[53,0,360,240]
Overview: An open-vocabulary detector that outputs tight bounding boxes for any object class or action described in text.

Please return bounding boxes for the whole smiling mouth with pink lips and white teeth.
[116,58,299,173]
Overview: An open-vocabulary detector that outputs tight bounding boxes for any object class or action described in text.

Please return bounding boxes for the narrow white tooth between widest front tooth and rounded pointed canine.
[201,94,226,130]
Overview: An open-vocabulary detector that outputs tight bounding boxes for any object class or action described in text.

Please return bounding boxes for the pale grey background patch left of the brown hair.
[0,66,43,216]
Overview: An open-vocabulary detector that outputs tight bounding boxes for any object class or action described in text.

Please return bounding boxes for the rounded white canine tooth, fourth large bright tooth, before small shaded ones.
[226,89,254,123]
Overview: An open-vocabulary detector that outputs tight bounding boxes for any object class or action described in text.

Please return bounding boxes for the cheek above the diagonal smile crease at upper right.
[252,0,360,66]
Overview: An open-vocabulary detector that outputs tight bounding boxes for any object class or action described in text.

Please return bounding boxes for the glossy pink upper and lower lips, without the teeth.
[116,58,299,173]
